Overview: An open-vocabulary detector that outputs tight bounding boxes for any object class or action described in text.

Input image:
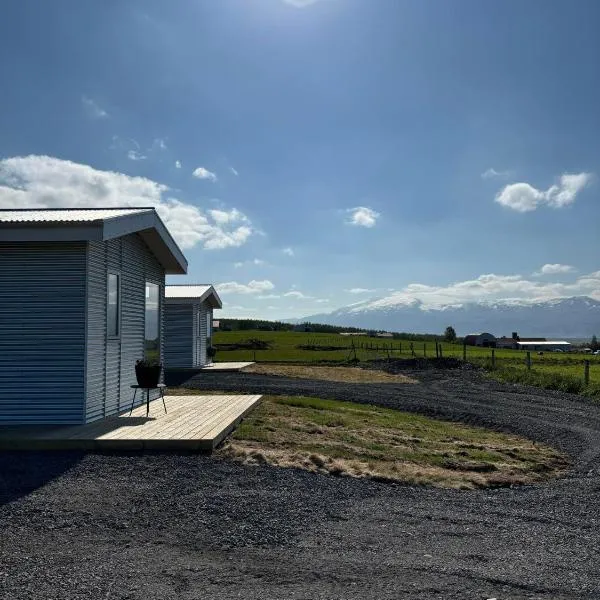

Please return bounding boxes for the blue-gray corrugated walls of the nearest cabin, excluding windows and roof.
[0,234,165,424]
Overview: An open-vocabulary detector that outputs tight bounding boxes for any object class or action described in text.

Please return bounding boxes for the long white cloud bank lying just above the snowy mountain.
[354,271,600,310]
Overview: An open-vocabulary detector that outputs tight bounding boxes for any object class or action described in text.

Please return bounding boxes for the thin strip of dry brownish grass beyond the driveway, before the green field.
[243,363,417,383]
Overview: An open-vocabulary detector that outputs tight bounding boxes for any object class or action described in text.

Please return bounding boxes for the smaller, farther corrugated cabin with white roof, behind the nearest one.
[165,285,223,368]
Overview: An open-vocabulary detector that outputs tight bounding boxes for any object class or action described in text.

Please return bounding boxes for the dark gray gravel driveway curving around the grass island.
[0,371,600,600]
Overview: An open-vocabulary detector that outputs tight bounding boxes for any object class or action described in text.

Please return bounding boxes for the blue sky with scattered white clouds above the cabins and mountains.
[0,0,600,318]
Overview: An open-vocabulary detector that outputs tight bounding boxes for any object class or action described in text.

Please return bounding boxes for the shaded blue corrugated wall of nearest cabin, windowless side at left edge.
[0,242,86,424]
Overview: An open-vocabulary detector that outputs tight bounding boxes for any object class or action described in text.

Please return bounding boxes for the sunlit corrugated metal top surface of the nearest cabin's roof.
[0,208,152,223]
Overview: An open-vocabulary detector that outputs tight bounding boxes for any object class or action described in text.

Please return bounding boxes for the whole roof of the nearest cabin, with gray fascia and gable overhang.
[0,207,187,275]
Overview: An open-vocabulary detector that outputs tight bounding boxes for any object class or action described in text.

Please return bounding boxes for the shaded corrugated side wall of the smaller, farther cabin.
[164,303,196,367]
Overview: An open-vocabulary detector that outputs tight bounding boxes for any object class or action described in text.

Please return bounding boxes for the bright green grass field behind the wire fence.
[213,331,600,386]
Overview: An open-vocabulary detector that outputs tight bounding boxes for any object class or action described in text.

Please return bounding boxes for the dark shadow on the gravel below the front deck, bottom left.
[0,451,84,506]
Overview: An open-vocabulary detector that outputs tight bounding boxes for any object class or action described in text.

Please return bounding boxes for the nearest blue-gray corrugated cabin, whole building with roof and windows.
[0,208,187,424]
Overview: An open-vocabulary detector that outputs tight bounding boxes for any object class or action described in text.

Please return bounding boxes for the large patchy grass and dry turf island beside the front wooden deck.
[218,396,569,489]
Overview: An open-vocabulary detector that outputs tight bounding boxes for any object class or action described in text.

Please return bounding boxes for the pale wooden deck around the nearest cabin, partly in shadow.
[0,395,261,452]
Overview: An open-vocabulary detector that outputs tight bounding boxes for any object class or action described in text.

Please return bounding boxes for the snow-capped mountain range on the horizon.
[300,296,600,338]
